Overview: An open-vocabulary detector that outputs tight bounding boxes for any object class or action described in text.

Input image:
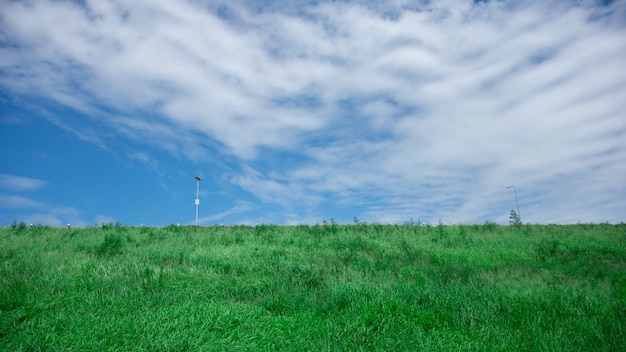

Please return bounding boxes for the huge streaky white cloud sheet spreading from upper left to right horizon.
[0,1,626,221]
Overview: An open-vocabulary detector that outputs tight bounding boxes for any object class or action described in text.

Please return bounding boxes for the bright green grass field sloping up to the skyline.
[0,223,626,351]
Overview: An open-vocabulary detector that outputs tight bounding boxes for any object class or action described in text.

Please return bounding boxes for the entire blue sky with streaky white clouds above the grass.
[0,0,626,226]
